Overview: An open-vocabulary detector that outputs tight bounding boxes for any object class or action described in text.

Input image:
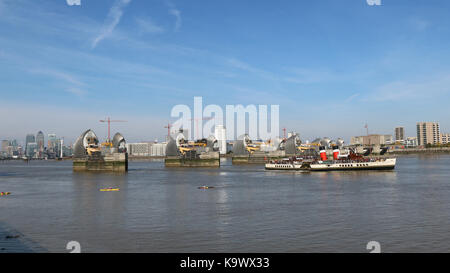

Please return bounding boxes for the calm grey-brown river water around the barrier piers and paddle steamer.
[0,155,450,253]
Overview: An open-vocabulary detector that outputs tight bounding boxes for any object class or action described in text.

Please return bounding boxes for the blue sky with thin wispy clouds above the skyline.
[0,0,450,142]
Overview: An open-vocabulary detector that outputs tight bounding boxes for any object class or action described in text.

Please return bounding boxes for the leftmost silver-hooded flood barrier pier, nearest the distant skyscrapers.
[73,129,128,172]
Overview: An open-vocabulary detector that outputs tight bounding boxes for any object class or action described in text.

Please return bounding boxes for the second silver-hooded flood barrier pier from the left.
[164,132,220,167]
